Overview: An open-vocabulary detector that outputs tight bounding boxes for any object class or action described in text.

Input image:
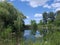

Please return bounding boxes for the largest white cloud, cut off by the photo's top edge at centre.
[21,0,49,7]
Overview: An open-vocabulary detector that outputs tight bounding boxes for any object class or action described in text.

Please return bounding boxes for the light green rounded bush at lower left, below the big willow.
[0,27,12,39]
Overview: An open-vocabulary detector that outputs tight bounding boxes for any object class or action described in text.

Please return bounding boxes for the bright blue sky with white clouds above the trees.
[6,0,60,24]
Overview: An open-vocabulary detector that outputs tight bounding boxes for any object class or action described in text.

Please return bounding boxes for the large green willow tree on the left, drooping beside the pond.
[0,2,26,45]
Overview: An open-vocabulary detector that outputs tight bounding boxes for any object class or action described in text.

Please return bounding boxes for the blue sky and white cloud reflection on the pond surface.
[24,30,42,41]
